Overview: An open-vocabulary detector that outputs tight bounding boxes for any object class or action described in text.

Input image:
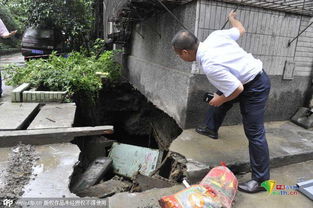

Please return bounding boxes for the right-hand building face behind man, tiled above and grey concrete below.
[185,0,313,128]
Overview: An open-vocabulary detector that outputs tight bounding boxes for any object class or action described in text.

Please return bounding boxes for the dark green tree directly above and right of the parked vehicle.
[27,0,94,50]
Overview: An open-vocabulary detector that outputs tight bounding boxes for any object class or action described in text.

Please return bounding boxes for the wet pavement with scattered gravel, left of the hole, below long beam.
[0,143,80,198]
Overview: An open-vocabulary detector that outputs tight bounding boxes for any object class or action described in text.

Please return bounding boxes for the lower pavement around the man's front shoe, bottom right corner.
[233,160,313,208]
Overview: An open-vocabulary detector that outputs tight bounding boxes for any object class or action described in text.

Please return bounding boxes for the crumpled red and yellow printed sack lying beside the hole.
[159,166,238,208]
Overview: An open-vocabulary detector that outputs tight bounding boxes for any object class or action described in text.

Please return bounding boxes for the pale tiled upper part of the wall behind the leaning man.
[196,0,313,76]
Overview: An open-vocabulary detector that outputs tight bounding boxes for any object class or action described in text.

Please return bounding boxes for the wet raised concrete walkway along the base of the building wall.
[170,121,313,180]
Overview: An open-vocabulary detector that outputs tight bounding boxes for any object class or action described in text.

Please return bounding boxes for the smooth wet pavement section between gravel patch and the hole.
[22,143,80,198]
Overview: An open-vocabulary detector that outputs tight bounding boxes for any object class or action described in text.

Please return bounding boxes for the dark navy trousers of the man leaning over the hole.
[205,72,271,182]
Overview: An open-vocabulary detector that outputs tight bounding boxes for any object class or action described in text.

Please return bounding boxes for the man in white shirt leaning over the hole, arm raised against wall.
[172,11,270,193]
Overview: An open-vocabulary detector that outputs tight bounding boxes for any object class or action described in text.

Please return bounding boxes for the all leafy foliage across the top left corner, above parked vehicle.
[0,0,94,50]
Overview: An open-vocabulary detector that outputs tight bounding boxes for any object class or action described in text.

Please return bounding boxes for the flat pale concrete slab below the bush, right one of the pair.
[27,103,76,129]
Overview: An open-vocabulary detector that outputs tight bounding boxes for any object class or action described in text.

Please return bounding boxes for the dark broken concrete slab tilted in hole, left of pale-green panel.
[72,157,112,193]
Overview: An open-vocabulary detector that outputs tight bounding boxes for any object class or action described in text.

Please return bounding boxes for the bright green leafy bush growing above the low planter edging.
[5,51,121,101]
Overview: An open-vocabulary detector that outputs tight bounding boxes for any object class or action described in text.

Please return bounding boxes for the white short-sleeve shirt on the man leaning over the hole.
[197,27,263,97]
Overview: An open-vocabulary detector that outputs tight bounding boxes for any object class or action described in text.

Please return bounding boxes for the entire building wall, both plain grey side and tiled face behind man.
[128,0,313,128]
